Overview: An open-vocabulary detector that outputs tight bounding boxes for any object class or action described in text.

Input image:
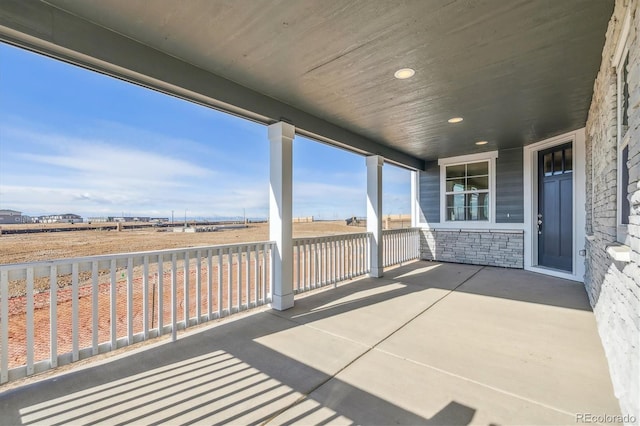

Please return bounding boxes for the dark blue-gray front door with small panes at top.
[537,143,573,272]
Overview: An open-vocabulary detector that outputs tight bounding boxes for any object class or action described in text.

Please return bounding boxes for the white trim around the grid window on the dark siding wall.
[434,151,500,229]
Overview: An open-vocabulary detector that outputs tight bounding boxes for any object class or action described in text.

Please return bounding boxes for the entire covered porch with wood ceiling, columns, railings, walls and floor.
[0,0,640,424]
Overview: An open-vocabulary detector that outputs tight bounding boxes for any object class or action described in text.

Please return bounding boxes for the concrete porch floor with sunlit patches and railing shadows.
[0,261,620,425]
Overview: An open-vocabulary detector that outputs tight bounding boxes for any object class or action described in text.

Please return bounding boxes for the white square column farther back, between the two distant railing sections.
[367,155,384,278]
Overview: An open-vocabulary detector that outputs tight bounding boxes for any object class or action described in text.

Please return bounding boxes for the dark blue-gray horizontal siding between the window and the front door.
[496,148,524,223]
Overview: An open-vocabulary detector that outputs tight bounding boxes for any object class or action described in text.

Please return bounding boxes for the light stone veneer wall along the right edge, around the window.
[585,0,640,424]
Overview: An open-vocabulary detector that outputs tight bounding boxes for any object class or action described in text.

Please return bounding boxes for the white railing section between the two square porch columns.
[293,232,371,293]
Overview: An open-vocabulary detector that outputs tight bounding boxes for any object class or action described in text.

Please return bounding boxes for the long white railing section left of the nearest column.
[0,242,273,383]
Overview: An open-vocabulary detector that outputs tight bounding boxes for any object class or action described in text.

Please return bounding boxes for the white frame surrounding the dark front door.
[523,128,586,282]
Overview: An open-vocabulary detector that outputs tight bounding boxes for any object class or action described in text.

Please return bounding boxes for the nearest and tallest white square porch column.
[269,122,295,311]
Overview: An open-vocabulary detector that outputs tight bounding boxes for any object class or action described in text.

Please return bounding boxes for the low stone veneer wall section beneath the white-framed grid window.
[420,229,524,269]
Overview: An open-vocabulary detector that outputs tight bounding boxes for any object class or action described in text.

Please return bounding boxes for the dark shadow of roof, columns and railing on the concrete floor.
[0,261,590,425]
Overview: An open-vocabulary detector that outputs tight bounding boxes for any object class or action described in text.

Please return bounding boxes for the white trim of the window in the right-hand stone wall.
[612,10,631,244]
